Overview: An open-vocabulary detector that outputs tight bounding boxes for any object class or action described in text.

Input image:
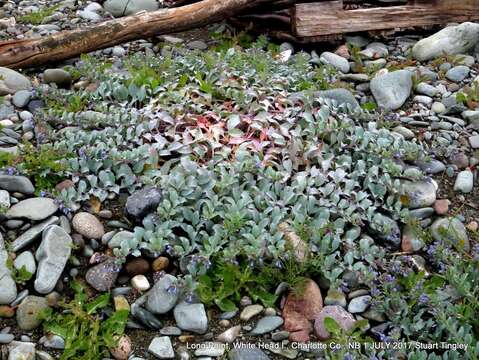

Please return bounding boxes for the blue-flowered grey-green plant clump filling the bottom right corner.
[373,230,479,359]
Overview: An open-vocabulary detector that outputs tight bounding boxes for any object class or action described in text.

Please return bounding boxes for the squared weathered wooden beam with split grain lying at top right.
[292,0,479,38]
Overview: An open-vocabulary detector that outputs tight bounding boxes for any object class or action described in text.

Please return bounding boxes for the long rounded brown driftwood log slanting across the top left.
[0,0,286,69]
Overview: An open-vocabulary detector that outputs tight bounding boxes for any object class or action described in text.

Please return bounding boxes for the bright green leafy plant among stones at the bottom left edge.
[42,282,129,360]
